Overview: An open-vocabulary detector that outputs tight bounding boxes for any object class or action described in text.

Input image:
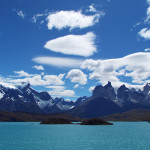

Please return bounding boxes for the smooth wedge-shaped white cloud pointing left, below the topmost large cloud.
[44,32,96,57]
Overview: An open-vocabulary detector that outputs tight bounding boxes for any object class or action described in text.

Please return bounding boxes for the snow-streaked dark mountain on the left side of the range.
[0,83,75,113]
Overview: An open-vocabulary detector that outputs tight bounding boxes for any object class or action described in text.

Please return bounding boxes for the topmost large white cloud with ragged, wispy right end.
[47,10,104,30]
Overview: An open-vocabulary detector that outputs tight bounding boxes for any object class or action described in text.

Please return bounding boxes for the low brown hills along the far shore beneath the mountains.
[0,109,150,122]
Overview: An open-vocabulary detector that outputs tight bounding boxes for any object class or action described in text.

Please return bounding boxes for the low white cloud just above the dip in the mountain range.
[47,86,76,97]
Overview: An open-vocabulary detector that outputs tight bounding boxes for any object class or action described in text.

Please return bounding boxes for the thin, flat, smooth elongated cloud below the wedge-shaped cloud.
[32,57,83,68]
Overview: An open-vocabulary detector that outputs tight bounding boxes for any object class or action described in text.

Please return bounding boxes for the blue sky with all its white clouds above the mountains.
[0,0,150,100]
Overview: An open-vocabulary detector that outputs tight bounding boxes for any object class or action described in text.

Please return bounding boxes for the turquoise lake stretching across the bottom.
[0,122,150,150]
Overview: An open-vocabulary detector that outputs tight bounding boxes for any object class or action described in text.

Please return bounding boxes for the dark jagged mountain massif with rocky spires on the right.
[71,82,150,118]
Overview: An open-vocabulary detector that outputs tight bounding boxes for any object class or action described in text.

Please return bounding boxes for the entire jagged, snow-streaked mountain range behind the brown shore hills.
[0,82,150,118]
